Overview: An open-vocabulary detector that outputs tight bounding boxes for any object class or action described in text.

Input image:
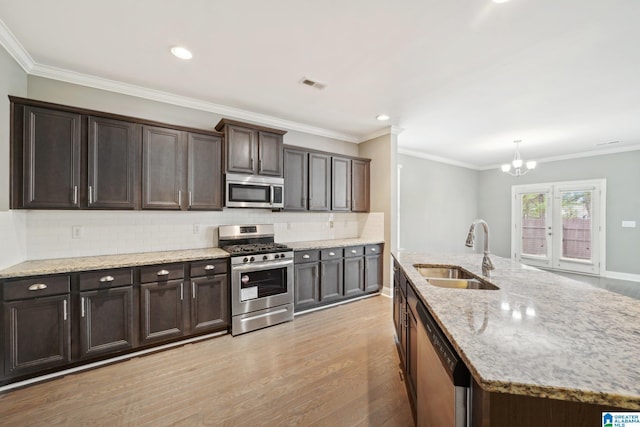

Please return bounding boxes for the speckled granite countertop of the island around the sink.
[393,252,640,410]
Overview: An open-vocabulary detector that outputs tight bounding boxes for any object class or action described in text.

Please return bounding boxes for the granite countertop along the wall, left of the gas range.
[0,248,229,279]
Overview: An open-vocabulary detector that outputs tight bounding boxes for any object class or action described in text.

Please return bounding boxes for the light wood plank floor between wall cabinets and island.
[0,296,413,426]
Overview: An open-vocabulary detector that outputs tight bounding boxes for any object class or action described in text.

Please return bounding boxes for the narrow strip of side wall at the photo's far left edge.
[0,43,27,268]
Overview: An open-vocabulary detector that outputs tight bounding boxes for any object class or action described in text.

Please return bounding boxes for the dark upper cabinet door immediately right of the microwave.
[284,148,308,211]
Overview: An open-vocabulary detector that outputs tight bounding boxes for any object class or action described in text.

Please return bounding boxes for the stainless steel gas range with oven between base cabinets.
[218,224,293,335]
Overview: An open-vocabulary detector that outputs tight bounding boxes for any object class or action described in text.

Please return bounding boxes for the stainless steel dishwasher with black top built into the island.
[416,301,471,427]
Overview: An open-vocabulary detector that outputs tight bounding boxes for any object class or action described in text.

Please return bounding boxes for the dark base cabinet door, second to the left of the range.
[140,280,184,344]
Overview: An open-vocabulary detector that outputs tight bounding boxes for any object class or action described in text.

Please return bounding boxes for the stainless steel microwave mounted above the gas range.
[225,173,284,209]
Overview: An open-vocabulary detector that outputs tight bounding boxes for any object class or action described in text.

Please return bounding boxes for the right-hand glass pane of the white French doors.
[561,190,593,260]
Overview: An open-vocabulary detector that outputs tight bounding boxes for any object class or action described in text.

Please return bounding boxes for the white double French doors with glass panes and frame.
[511,180,606,274]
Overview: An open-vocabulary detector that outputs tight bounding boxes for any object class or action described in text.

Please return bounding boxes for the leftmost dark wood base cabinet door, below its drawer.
[3,294,71,376]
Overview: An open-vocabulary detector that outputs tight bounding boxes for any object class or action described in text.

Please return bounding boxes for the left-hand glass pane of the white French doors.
[521,193,547,256]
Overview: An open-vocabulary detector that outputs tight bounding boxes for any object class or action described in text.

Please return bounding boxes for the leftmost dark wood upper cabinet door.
[21,107,82,209]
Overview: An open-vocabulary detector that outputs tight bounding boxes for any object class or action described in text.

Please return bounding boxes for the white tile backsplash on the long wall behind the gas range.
[25,209,384,260]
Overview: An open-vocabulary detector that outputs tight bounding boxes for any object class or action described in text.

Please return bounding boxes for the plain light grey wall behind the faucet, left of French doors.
[398,154,478,253]
